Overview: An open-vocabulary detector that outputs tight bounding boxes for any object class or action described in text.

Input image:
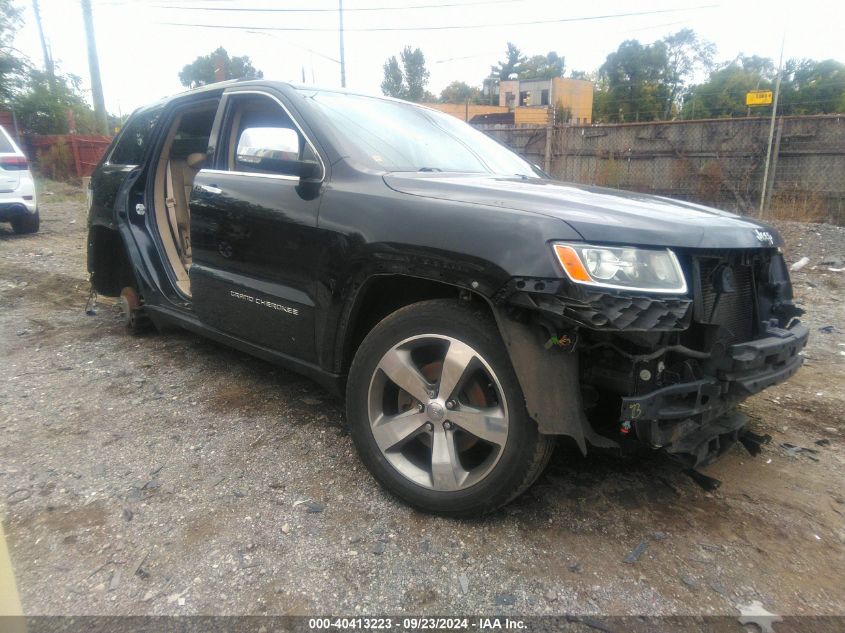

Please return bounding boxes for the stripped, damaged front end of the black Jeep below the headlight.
[499,248,808,468]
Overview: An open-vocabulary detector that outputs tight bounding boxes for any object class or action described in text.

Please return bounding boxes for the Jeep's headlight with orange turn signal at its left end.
[553,244,687,294]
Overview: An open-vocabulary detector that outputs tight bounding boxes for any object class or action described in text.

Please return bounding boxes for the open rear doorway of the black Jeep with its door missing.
[154,101,217,297]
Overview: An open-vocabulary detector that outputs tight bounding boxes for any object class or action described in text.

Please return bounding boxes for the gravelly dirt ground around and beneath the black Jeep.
[0,186,845,615]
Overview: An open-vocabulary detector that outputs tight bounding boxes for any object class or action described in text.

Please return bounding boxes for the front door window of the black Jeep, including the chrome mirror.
[226,95,317,176]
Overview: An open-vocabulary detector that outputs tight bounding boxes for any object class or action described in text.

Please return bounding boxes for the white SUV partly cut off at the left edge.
[0,125,40,233]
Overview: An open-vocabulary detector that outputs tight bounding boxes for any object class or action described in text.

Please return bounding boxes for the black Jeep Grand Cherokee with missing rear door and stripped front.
[88,81,808,516]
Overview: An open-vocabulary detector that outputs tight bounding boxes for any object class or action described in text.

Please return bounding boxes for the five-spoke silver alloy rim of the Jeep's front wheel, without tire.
[368,334,508,492]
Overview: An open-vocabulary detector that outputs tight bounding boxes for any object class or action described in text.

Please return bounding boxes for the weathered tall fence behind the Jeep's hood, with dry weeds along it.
[477,115,845,225]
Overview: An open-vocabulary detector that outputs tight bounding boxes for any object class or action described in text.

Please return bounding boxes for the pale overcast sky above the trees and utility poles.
[11,0,845,114]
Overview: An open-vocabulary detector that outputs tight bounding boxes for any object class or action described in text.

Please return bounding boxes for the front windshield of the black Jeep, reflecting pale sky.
[310,91,540,178]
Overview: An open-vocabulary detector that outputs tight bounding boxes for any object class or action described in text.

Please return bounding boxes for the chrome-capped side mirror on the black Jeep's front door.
[235,127,320,180]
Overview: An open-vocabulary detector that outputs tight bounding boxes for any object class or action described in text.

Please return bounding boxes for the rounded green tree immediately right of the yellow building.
[593,40,670,121]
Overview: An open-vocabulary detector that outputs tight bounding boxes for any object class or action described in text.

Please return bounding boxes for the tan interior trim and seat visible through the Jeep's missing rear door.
[154,108,214,297]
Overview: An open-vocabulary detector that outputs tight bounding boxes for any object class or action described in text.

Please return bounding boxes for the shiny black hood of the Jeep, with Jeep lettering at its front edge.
[384,172,781,248]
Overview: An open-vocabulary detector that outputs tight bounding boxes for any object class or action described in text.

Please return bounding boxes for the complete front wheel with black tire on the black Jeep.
[347,300,554,517]
